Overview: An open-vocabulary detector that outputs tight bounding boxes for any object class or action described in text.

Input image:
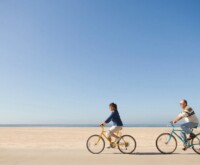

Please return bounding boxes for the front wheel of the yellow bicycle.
[86,135,105,154]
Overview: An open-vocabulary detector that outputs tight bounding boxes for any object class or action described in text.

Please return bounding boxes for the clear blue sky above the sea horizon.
[0,0,200,124]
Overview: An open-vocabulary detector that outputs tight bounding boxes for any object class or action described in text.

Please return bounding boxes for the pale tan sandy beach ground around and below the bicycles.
[0,127,200,165]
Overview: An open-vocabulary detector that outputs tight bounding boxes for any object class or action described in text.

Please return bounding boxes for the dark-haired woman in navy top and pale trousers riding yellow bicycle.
[100,103,123,147]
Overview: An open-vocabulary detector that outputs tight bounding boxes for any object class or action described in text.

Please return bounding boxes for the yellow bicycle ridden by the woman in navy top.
[86,126,136,154]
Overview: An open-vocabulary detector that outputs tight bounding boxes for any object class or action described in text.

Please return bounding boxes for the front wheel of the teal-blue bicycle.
[156,133,177,154]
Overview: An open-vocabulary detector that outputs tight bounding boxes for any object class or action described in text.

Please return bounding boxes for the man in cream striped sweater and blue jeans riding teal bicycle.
[172,99,199,151]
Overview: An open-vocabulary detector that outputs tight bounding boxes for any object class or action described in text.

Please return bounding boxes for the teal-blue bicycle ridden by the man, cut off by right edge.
[156,123,200,154]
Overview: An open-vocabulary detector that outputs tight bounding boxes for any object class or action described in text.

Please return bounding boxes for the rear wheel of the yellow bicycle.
[118,135,136,154]
